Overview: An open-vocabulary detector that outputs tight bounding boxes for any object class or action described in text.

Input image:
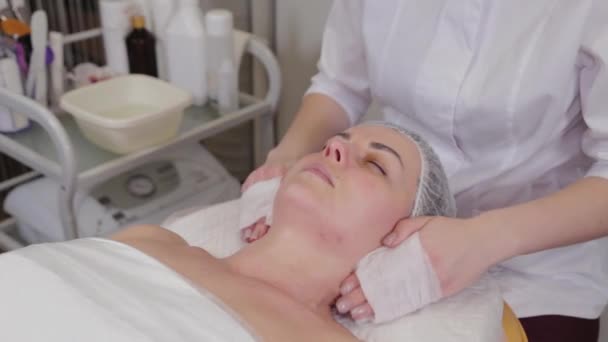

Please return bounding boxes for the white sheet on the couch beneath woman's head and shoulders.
[163,196,504,342]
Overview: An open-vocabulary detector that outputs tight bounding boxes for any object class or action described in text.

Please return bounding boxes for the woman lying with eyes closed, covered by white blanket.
[0,124,524,341]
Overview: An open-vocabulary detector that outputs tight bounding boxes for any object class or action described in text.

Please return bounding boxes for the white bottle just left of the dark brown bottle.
[99,0,133,74]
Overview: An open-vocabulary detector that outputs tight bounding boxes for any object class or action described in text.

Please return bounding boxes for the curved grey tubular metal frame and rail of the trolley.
[0,29,281,250]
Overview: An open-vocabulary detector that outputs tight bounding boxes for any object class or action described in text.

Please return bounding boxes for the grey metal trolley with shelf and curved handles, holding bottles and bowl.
[0,29,281,250]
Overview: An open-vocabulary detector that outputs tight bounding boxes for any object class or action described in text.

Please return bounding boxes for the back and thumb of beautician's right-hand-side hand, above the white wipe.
[383,217,500,297]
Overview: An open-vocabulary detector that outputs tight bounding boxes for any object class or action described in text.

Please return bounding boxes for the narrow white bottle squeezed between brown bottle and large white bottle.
[150,0,175,81]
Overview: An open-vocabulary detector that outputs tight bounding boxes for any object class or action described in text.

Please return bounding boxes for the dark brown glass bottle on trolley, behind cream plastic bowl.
[125,16,158,77]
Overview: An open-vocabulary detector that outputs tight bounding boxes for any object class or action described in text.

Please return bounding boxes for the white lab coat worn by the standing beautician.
[308,0,608,318]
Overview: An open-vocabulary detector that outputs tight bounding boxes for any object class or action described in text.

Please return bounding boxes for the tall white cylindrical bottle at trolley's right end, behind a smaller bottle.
[205,9,237,100]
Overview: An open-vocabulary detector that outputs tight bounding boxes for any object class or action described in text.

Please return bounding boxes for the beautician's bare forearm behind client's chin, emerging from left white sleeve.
[267,94,350,162]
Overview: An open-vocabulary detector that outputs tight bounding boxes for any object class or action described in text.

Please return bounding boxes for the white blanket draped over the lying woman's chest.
[0,239,254,342]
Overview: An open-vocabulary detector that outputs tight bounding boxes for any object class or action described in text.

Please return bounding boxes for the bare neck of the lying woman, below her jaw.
[226,225,353,316]
